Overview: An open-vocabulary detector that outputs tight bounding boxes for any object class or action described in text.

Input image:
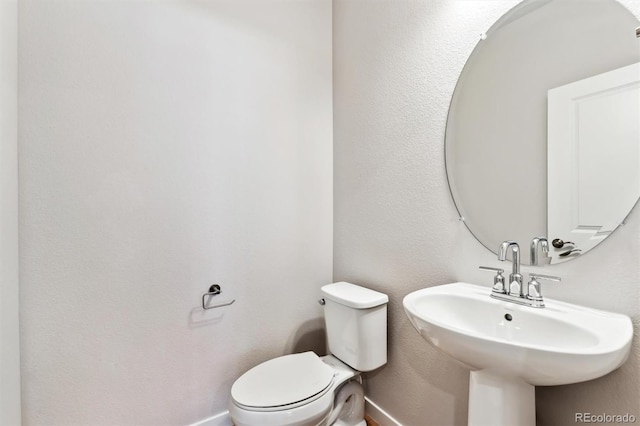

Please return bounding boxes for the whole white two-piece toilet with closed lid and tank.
[229,282,389,426]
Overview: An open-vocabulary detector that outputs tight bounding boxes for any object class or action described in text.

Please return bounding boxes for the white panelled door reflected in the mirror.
[547,64,640,263]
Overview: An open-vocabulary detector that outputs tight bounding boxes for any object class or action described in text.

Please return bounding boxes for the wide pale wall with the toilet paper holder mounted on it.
[19,0,332,425]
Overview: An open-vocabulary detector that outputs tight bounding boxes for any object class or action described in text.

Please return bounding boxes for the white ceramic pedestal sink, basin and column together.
[403,283,633,426]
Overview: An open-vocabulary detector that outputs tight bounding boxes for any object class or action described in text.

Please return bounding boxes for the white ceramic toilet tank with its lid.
[321,282,389,371]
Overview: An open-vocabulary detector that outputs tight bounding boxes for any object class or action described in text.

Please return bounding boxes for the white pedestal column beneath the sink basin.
[469,370,536,426]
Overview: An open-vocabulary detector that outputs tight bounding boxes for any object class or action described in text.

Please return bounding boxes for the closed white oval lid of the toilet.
[231,352,333,408]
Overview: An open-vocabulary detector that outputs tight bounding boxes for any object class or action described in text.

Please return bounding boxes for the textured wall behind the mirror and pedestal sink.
[333,0,640,426]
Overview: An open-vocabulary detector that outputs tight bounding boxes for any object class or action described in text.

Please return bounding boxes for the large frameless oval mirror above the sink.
[445,0,640,264]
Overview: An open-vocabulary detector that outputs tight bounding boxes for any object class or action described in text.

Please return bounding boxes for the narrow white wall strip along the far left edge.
[0,0,20,425]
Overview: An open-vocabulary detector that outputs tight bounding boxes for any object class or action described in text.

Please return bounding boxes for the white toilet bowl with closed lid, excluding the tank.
[229,352,366,426]
